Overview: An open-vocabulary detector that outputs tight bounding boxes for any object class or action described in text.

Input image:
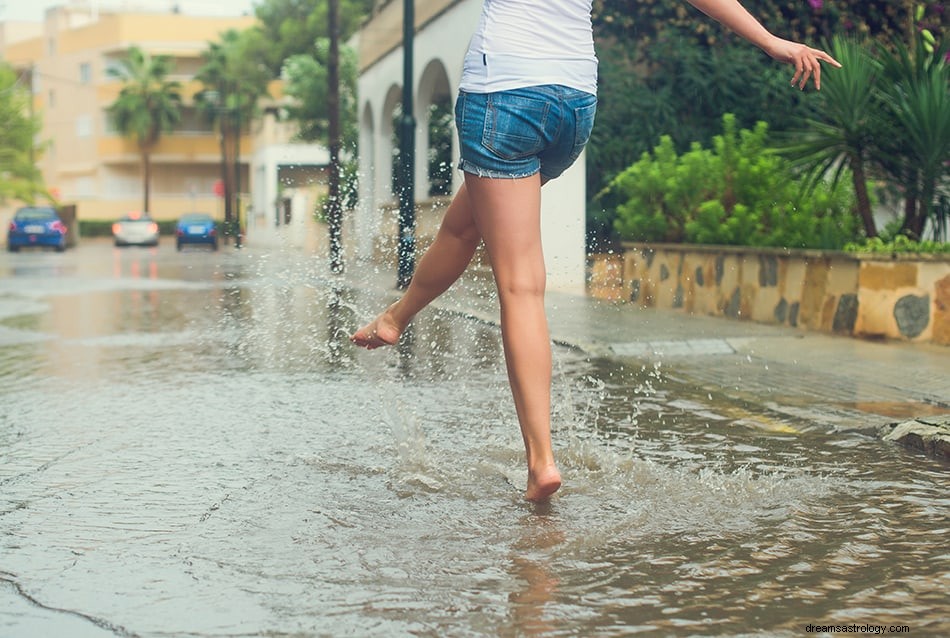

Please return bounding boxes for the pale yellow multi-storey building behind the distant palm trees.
[0,6,255,220]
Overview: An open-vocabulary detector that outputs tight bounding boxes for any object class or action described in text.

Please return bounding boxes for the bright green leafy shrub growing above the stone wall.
[600,114,859,248]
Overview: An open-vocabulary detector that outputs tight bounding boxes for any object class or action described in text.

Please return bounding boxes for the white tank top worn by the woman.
[459,0,597,94]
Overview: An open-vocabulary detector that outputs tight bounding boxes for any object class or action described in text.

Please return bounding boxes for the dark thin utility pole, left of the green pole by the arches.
[326,0,343,273]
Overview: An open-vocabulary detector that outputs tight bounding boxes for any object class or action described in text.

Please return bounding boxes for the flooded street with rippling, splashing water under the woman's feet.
[0,240,950,638]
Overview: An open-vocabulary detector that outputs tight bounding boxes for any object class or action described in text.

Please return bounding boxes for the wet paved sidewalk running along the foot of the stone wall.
[350,262,950,438]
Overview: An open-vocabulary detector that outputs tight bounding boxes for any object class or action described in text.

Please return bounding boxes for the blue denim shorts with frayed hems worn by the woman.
[455,84,597,179]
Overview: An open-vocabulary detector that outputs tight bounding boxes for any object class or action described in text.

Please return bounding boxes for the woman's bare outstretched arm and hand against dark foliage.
[687,0,841,89]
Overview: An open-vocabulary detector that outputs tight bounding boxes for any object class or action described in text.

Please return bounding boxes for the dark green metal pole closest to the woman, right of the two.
[396,0,416,288]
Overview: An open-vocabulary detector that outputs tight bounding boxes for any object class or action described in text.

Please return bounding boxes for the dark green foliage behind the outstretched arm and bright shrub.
[587,0,947,244]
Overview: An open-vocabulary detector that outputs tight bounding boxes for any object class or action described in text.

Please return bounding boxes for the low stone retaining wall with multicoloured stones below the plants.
[588,243,950,345]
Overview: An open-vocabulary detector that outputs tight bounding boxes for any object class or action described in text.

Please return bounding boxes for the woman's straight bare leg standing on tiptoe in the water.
[465,173,561,501]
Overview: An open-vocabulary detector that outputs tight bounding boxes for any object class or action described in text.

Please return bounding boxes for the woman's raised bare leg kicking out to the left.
[350,185,481,350]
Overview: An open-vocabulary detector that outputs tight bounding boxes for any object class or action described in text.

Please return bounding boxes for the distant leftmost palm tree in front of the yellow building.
[108,46,181,212]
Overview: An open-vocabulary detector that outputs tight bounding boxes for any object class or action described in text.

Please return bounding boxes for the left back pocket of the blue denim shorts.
[482,92,551,160]
